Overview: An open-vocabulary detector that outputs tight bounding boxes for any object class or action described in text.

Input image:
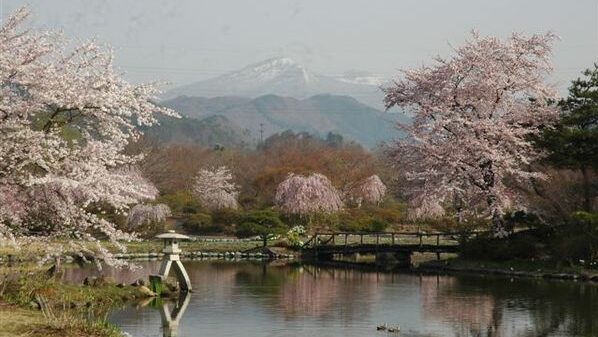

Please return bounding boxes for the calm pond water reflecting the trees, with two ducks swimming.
[66,261,598,337]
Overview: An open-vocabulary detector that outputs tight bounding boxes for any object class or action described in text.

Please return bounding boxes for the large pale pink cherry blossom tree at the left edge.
[0,8,175,262]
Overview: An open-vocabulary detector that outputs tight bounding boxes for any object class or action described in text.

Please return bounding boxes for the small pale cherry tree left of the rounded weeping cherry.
[191,166,239,209]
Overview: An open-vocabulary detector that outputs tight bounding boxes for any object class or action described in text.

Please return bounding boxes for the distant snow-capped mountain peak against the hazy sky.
[163,57,384,109]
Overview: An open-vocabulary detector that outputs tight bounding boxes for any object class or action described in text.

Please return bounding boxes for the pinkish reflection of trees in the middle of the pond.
[236,265,380,321]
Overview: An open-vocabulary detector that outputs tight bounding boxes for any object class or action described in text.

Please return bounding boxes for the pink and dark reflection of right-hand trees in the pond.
[421,276,598,337]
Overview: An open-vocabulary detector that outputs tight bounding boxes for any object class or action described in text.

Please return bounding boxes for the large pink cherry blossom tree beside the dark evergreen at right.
[385,32,557,236]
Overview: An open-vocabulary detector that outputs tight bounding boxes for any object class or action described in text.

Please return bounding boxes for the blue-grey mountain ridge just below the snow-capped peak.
[162,94,401,147]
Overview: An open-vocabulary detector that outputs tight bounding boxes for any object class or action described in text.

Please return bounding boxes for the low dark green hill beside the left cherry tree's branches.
[143,115,252,147]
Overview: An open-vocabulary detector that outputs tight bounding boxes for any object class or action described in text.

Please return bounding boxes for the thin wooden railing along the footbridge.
[303,231,487,249]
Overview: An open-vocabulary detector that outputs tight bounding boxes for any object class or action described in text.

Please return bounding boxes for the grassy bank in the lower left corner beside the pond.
[0,270,155,337]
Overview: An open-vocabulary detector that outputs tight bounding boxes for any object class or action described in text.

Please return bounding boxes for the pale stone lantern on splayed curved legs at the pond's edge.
[152,230,191,291]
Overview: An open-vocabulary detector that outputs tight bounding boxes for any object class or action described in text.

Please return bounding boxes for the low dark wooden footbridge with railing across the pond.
[302,231,486,266]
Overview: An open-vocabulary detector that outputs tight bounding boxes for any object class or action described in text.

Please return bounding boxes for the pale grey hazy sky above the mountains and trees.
[0,0,598,90]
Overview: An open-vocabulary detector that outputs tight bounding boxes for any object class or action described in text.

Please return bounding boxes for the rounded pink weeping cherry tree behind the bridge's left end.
[274,173,343,216]
